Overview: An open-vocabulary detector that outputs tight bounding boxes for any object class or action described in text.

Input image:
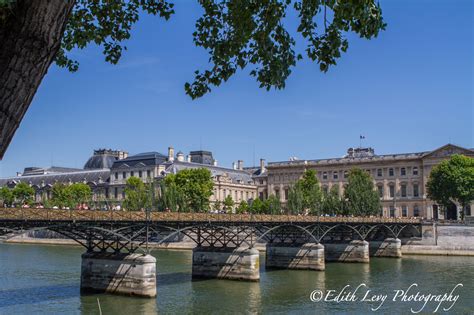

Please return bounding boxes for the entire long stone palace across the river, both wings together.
[0,144,474,219]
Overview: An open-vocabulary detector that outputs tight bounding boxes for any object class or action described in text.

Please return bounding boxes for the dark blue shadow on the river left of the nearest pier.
[0,284,79,309]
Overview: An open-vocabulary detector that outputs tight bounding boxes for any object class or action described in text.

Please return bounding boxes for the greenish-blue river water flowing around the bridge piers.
[0,244,474,315]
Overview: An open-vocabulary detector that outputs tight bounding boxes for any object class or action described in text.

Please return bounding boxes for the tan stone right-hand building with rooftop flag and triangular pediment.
[260,144,474,219]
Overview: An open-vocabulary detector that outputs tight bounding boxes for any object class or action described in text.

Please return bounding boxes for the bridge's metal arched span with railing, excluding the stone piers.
[0,209,421,253]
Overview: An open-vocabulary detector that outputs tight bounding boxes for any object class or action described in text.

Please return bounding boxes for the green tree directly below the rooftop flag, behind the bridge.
[344,168,380,216]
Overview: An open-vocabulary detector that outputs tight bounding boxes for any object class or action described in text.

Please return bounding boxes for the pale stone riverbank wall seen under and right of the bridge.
[5,236,474,256]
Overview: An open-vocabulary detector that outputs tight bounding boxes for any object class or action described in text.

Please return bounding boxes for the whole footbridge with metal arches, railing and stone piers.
[0,208,422,296]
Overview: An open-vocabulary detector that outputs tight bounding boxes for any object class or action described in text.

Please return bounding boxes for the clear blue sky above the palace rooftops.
[0,0,474,177]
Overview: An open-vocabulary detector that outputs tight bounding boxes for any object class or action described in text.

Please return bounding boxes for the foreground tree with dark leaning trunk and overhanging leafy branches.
[0,0,385,158]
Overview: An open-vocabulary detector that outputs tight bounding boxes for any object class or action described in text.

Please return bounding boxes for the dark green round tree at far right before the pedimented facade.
[426,154,474,219]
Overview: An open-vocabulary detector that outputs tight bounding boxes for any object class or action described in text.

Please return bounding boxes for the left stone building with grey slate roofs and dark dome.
[0,147,257,211]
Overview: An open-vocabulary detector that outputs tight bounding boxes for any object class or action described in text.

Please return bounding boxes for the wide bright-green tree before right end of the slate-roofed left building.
[165,168,214,212]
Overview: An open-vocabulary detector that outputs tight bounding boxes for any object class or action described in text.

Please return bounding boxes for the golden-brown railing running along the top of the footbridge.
[0,208,421,223]
